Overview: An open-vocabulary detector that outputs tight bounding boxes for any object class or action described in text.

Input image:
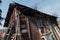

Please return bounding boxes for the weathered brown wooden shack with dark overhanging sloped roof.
[4,3,58,40]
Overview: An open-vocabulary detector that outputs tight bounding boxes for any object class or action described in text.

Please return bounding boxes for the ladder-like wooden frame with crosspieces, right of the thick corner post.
[20,15,30,40]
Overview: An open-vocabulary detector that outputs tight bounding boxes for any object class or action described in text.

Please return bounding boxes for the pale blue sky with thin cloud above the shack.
[0,0,60,29]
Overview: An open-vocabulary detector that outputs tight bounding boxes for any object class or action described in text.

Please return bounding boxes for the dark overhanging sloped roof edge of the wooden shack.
[4,3,57,27]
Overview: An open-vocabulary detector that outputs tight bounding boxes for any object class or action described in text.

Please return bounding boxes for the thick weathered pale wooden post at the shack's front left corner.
[15,8,21,40]
